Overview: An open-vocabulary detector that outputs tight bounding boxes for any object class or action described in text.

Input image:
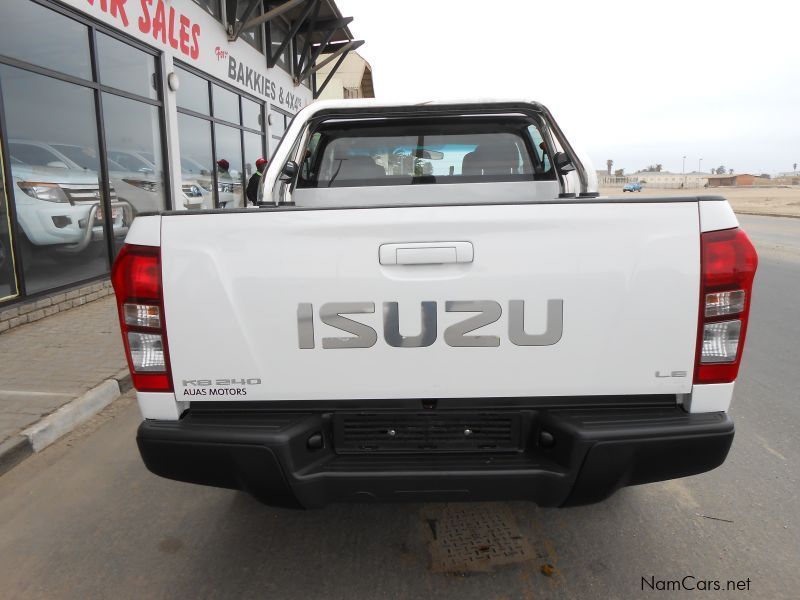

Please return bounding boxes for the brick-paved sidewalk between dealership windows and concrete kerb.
[0,296,126,444]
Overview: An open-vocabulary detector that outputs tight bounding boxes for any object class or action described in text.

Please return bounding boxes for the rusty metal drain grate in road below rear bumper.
[426,504,535,573]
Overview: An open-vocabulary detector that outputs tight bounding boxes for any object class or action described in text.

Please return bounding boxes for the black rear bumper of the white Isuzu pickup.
[137,407,734,508]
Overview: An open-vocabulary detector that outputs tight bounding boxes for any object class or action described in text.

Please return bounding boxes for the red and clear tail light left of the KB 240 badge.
[111,244,172,392]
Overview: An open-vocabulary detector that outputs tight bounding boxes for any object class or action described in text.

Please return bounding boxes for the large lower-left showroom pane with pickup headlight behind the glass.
[0,66,108,293]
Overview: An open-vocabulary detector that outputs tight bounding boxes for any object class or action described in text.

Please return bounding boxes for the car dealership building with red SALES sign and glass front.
[0,0,363,332]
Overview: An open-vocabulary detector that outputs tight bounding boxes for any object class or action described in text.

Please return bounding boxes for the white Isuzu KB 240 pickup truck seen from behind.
[112,100,757,507]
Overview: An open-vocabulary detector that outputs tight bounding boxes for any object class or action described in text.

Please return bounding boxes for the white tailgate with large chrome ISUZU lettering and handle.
[161,199,700,401]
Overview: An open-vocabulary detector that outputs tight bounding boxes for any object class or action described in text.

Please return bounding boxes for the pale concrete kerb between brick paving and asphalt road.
[0,369,132,475]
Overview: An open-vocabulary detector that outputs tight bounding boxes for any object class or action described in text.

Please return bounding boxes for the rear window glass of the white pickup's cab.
[298,118,555,188]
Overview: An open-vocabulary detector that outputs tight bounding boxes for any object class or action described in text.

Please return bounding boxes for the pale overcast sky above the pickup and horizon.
[336,0,800,174]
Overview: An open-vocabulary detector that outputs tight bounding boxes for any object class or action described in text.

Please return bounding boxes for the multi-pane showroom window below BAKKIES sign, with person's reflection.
[175,65,266,209]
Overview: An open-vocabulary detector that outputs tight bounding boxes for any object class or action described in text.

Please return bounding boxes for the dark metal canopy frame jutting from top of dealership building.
[228,0,364,99]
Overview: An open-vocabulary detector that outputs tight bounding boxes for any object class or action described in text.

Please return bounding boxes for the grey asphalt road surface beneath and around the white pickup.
[0,216,800,600]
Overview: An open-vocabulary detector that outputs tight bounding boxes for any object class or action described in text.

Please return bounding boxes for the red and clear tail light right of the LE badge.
[694,228,758,383]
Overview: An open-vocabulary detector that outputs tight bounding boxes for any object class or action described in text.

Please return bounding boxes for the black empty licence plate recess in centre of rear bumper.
[333,411,522,454]
